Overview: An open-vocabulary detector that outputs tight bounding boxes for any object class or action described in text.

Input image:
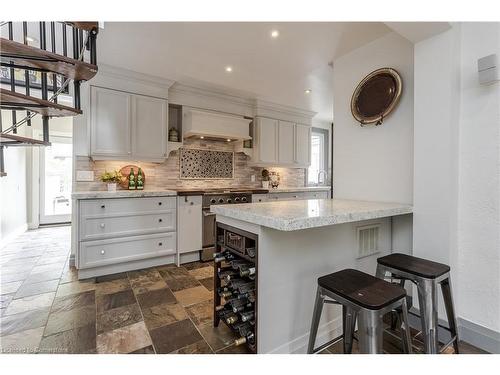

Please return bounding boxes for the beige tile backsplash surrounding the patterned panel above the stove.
[73,139,305,191]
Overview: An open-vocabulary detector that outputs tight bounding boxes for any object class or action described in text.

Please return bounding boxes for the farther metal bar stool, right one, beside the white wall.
[377,253,459,354]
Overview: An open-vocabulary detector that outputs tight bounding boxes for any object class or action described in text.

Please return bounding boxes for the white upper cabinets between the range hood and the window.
[252,117,311,168]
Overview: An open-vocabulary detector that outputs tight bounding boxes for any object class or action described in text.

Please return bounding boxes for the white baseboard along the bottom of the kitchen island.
[269,317,342,354]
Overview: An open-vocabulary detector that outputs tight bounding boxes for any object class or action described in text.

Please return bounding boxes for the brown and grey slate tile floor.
[0,226,482,354]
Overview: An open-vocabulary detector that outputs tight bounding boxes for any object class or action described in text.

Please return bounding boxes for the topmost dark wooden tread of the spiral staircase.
[0,38,97,81]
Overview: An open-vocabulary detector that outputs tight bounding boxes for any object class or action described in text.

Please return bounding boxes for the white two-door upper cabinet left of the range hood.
[90,86,168,162]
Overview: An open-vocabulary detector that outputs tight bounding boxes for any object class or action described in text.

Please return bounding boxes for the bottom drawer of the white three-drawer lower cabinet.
[79,232,176,268]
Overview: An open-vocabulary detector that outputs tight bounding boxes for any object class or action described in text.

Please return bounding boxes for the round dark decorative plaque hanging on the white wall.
[351,68,403,126]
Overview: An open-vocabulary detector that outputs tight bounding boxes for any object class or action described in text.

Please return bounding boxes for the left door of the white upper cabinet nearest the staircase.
[90,87,131,159]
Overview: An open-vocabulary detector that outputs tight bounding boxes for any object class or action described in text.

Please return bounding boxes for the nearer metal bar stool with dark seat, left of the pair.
[307,269,411,353]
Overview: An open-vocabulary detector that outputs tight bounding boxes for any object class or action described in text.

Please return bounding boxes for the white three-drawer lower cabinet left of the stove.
[75,197,177,279]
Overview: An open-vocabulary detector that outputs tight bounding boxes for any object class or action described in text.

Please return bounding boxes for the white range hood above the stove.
[182,109,252,141]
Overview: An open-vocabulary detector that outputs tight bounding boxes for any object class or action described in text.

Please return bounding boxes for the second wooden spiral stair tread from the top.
[0,89,82,117]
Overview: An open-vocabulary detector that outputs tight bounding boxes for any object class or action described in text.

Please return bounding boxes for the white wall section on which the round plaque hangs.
[333,33,413,203]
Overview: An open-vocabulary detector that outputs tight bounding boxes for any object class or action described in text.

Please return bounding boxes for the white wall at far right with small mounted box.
[413,23,500,351]
